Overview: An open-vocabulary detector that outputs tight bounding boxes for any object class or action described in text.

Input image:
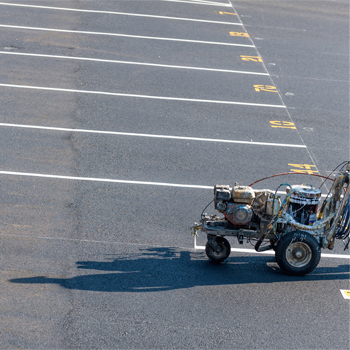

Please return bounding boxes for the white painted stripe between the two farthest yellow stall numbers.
[0,2,238,26]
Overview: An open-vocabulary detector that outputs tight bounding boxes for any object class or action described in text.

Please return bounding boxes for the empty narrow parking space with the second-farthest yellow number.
[0,4,245,45]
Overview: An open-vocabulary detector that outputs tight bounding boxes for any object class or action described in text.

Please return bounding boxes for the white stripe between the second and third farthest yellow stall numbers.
[0,24,255,48]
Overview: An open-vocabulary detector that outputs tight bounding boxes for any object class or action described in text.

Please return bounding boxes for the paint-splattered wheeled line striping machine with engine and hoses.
[191,161,350,276]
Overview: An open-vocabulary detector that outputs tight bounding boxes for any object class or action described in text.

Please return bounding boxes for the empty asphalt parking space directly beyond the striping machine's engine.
[1,127,309,185]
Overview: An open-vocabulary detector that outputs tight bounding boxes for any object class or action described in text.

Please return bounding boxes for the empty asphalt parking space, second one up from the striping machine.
[2,88,300,144]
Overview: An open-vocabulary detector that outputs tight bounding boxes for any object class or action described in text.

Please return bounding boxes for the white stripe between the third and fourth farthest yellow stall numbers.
[0,51,269,76]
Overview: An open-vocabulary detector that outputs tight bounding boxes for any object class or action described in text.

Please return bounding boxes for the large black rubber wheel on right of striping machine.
[275,231,321,276]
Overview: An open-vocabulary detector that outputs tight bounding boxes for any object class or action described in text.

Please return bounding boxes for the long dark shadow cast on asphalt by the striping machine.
[10,248,350,293]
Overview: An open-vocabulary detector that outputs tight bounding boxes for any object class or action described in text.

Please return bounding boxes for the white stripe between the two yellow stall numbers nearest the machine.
[0,123,306,148]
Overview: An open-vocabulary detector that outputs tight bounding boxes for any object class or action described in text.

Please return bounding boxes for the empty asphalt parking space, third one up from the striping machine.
[1,55,284,103]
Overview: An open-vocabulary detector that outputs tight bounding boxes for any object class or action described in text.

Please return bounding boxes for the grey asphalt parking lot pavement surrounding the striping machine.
[0,0,350,350]
